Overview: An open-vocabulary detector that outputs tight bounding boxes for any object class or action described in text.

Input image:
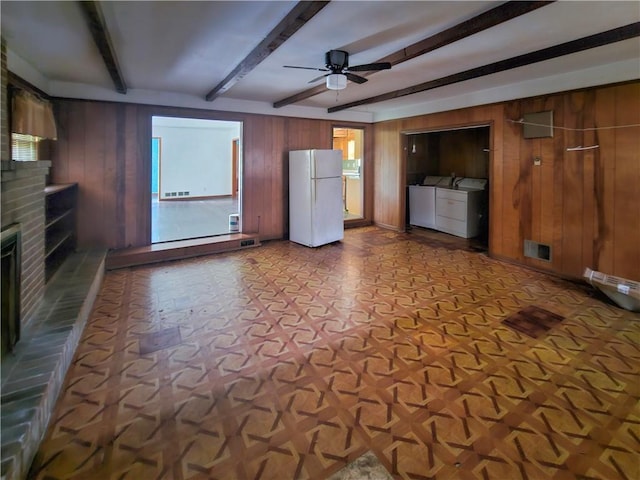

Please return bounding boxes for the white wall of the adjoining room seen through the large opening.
[153,117,240,199]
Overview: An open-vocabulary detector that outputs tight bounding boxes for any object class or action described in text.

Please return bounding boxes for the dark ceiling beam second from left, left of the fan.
[205,1,329,102]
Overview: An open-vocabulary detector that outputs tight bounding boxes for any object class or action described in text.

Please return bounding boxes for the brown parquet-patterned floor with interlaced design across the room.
[31,227,640,480]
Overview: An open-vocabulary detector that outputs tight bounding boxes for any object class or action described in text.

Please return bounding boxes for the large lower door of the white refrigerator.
[311,178,344,247]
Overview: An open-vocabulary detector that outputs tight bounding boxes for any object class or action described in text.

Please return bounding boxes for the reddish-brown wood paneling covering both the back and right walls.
[51,82,640,280]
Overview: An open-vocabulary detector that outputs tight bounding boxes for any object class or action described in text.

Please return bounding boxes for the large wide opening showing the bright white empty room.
[150,116,242,243]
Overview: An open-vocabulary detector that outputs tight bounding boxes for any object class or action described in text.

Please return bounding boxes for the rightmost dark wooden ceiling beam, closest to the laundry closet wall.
[327,22,640,113]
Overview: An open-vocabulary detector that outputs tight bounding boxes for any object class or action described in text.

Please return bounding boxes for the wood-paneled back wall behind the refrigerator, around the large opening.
[51,99,373,248]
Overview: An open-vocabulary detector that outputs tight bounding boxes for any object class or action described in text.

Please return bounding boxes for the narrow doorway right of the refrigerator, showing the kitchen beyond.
[333,127,364,220]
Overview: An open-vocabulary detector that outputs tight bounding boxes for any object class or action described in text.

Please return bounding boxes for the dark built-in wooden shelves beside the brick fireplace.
[44,183,78,281]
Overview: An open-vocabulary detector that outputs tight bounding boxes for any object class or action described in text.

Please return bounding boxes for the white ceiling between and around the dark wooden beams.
[1,0,640,122]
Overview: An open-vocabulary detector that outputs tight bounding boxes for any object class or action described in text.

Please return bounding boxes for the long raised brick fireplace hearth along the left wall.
[0,249,106,480]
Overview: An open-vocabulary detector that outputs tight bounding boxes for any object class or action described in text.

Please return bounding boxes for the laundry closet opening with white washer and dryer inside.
[404,125,491,249]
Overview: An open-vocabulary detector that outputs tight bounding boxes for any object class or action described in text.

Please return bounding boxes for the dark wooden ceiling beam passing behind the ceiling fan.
[273,1,553,108]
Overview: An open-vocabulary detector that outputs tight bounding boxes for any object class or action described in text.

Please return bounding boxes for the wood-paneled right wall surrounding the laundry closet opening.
[374,82,640,280]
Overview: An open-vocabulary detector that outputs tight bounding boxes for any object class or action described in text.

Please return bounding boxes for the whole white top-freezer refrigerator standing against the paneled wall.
[289,150,344,247]
